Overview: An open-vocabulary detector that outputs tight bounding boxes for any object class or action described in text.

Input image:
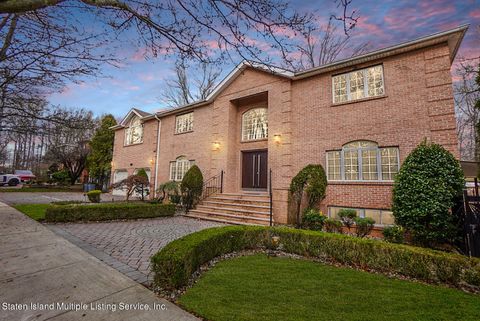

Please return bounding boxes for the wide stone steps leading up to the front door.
[186,193,270,226]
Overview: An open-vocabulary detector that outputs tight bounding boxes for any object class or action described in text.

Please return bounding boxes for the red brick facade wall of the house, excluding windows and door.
[110,44,459,223]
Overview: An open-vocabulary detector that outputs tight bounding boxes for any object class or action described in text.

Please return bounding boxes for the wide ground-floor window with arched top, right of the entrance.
[326,141,400,181]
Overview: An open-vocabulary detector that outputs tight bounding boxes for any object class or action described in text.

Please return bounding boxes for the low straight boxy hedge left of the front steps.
[45,203,175,222]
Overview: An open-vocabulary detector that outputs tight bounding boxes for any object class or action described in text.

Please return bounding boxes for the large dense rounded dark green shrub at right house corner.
[393,141,465,246]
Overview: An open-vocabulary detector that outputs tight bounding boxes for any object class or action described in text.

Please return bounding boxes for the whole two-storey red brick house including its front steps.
[112,26,467,226]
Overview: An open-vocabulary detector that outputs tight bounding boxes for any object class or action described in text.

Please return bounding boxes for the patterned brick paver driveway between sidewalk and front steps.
[47,216,222,285]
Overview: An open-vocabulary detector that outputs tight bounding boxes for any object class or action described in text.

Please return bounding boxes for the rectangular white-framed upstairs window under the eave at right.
[332,65,385,103]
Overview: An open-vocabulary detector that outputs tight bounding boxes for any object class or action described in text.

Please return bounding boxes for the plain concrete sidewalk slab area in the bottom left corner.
[0,203,198,321]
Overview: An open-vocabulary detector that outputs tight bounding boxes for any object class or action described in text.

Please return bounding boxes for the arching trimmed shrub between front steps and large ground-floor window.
[289,164,327,226]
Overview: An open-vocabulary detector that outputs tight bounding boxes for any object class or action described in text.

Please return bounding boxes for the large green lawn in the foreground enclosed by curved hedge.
[179,255,480,321]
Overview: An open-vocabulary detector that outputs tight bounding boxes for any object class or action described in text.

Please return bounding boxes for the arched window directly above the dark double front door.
[242,108,268,141]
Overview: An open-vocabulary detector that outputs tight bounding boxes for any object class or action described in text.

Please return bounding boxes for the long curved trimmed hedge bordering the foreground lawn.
[151,226,480,289]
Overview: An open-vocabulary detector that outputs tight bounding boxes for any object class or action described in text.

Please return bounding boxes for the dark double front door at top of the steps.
[242,150,268,189]
